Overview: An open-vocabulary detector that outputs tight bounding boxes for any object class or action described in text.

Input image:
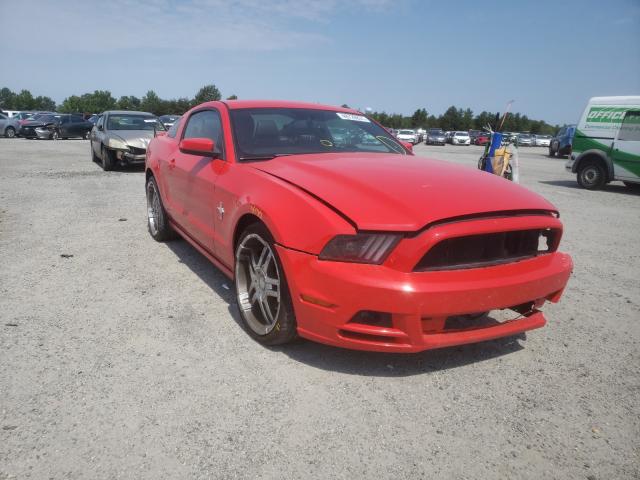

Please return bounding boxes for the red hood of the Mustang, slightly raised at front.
[252,153,556,231]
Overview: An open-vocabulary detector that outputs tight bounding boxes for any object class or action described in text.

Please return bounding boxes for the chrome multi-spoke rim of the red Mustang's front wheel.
[235,233,281,335]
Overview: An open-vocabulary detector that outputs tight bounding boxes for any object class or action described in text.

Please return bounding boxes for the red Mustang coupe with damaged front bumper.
[146,101,572,352]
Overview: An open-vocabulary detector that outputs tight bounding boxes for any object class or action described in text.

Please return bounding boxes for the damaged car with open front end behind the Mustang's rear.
[90,110,165,171]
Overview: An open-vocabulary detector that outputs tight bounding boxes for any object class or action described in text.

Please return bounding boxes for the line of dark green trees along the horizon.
[0,84,559,134]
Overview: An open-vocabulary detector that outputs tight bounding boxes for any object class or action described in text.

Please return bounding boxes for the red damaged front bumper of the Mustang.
[277,216,573,352]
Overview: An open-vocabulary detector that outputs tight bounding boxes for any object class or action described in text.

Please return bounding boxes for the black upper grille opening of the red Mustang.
[414,229,560,272]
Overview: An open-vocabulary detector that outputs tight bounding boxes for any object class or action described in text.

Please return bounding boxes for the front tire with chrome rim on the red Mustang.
[234,223,297,345]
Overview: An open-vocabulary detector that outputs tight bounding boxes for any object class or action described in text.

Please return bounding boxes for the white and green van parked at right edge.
[565,96,640,190]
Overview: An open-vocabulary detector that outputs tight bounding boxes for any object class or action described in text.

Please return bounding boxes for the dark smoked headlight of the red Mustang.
[318,233,401,265]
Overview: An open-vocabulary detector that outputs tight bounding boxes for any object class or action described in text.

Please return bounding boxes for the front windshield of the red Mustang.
[231,108,406,160]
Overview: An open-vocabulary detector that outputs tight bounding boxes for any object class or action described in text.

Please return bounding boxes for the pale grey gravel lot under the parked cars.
[0,138,640,480]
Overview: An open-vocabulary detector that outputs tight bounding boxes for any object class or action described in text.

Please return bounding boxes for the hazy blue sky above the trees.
[0,0,640,124]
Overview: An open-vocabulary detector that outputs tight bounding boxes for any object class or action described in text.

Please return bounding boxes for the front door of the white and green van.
[611,110,640,182]
